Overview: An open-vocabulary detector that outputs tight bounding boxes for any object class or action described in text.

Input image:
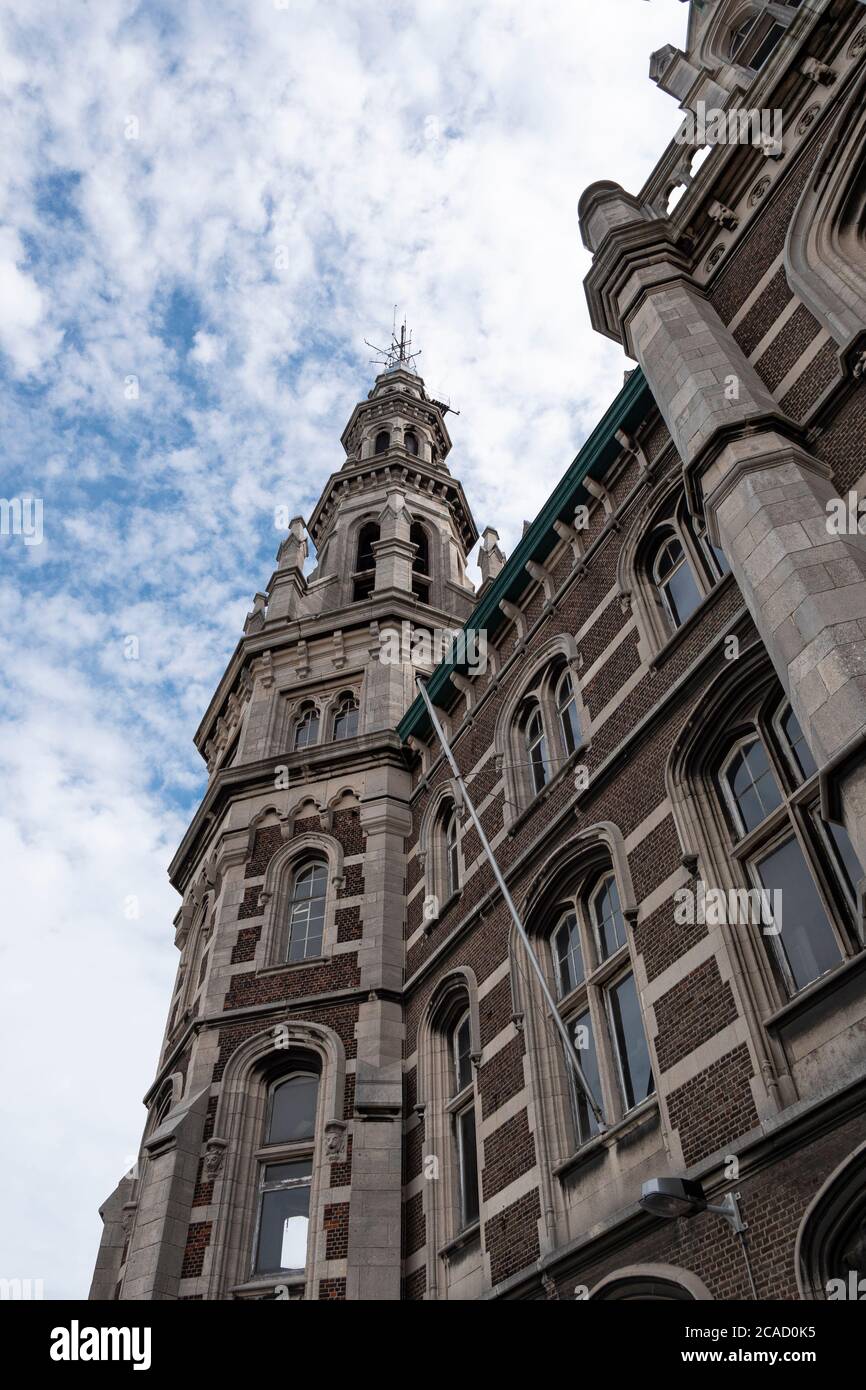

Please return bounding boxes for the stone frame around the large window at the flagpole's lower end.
[509,821,647,1178]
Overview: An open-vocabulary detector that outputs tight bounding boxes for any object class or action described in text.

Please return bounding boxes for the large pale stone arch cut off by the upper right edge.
[785,63,866,353]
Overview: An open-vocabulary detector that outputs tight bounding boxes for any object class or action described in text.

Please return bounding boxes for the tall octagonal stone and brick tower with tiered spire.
[90,344,477,1300]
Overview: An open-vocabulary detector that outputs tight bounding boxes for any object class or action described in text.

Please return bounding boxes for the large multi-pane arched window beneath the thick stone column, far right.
[719,701,863,1002]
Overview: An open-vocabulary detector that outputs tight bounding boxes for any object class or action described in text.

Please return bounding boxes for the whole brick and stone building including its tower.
[92,0,866,1300]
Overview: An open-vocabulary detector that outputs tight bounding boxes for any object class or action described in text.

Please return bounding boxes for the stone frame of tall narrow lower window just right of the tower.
[416,966,484,1298]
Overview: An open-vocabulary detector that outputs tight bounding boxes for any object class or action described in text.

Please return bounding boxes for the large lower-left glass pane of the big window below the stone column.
[755,837,840,990]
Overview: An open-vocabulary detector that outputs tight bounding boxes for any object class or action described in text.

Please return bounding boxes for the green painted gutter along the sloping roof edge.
[398,367,653,742]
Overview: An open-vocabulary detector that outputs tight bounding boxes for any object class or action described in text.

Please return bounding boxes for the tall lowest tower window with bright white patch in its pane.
[253,1072,318,1275]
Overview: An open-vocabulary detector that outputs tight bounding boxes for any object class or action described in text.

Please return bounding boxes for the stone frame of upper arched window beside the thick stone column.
[617,475,730,666]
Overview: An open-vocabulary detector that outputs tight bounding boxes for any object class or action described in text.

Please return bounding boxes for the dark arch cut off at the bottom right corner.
[794,1141,866,1300]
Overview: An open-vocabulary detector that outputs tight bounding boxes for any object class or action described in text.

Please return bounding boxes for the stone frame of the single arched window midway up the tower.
[260,830,345,970]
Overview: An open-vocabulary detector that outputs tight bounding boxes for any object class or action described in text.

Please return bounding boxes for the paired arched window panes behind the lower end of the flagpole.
[549,869,655,1144]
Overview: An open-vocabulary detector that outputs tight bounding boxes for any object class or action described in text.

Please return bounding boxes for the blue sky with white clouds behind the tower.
[0,0,687,1297]
